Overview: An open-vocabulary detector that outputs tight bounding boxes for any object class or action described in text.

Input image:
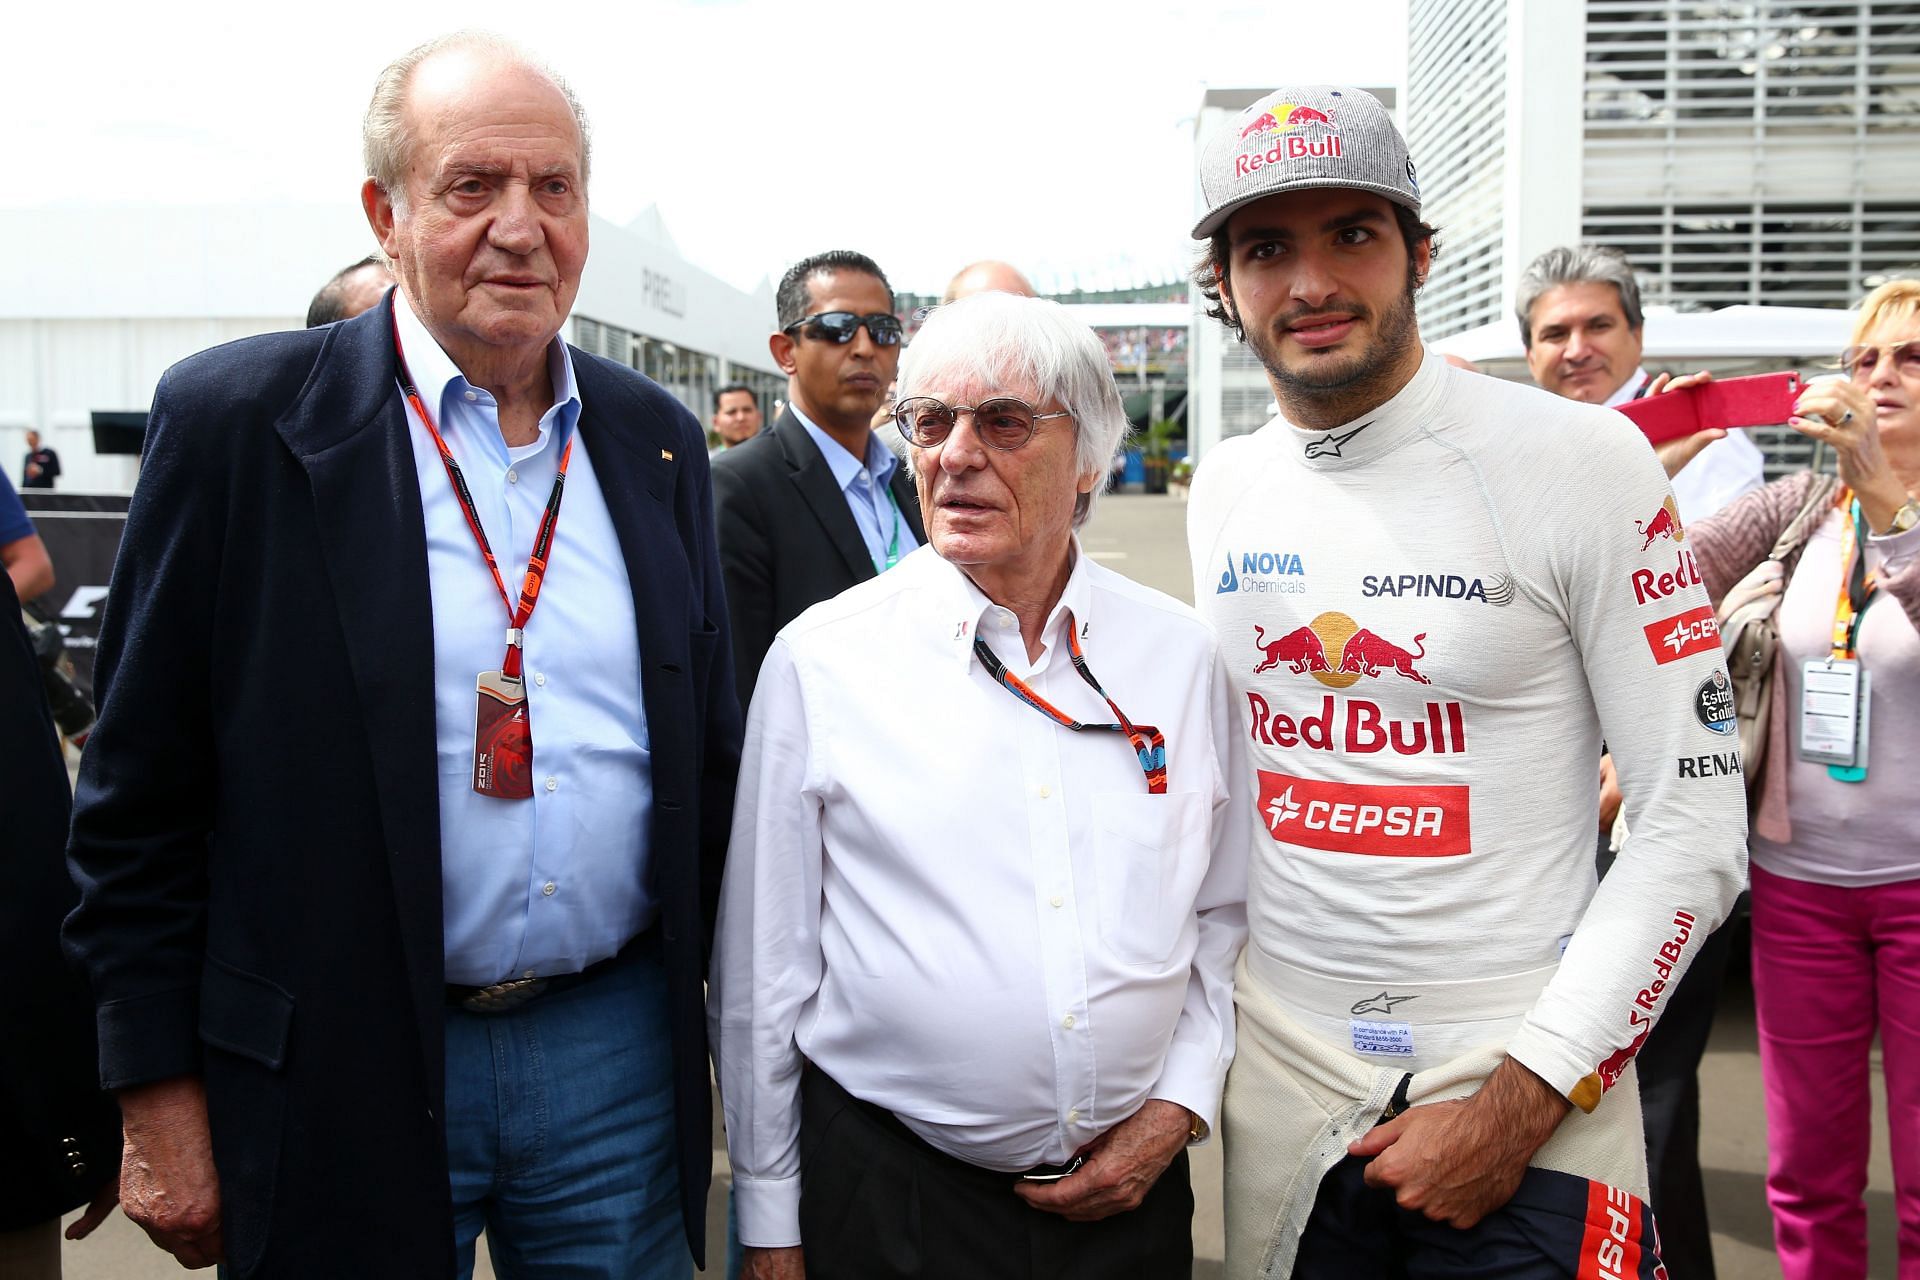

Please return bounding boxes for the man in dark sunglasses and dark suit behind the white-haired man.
[714,249,927,706]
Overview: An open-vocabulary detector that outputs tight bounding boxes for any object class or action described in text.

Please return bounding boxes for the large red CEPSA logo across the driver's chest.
[1258,770,1473,858]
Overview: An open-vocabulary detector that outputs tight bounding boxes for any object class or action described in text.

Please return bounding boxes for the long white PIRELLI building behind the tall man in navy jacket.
[0,203,787,491]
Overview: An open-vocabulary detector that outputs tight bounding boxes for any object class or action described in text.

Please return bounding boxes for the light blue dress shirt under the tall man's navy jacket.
[393,290,657,986]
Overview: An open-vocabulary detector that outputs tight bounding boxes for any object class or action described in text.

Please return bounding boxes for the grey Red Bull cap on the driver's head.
[1194,84,1421,240]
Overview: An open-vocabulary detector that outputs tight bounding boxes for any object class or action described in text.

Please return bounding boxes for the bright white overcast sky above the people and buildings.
[0,0,1405,292]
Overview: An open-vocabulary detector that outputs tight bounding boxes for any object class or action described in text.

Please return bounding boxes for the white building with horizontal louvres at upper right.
[1405,0,1920,340]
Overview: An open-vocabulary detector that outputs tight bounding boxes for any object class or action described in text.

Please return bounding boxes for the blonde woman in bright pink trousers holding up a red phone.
[1657,280,1920,1280]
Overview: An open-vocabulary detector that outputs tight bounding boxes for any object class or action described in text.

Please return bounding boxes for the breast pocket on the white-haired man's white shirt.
[1092,791,1208,967]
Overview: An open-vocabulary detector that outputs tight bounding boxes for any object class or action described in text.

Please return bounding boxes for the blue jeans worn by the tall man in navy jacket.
[447,946,693,1280]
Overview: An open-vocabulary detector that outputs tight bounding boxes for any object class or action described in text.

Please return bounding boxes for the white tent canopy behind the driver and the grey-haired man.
[1432,305,1855,382]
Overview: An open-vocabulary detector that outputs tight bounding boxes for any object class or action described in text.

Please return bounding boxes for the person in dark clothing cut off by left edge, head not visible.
[0,580,121,1280]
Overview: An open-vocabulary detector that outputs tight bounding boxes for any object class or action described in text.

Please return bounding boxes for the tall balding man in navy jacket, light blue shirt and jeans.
[67,36,739,1280]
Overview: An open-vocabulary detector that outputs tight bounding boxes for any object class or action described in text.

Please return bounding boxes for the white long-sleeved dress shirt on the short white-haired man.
[708,547,1250,1247]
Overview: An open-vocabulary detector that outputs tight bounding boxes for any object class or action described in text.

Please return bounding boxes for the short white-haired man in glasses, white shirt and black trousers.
[708,294,1248,1280]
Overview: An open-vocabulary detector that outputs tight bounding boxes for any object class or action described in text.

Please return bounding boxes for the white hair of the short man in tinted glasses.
[895,294,1129,528]
